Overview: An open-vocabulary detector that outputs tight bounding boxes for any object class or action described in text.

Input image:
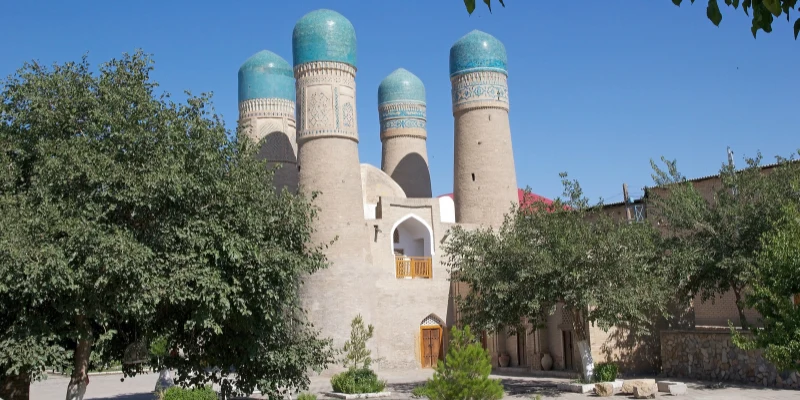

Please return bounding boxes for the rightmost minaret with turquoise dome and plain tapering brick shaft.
[450,30,519,227]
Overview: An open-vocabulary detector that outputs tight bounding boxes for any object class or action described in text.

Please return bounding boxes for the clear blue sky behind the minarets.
[0,0,800,202]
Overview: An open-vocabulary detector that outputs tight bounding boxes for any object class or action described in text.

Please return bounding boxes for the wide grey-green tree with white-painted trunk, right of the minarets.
[443,174,672,378]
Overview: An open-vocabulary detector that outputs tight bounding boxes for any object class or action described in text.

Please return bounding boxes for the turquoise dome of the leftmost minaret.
[239,50,294,103]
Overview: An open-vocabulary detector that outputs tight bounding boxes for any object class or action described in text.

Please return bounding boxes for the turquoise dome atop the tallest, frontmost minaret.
[292,9,356,67]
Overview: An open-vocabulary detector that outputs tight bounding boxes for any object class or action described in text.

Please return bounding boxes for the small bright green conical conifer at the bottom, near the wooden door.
[414,325,503,400]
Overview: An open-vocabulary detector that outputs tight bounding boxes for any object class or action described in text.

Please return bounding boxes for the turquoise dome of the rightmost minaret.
[450,30,508,76]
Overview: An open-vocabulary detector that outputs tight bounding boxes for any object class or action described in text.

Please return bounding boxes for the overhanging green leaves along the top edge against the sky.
[464,0,800,40]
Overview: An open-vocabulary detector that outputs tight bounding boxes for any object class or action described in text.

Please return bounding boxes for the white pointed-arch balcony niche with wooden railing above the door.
[391,214,434,279]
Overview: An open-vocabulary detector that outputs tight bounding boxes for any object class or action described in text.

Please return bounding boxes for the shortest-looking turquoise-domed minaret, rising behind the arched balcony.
[378,68,431,198]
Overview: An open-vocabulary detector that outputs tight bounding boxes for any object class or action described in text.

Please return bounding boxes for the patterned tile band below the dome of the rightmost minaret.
[450,71,509,113]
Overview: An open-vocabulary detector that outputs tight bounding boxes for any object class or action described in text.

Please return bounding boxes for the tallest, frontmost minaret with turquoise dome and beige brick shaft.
[292,9,376,354]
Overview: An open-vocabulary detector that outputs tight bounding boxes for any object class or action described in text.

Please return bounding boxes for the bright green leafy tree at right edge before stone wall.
[733,202,800,371]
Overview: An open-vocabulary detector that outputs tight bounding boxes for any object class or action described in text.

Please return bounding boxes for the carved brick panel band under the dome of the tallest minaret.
[294,61,358,142]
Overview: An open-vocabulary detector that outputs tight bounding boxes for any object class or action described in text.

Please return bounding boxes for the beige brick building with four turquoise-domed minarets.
[234,10,596,370]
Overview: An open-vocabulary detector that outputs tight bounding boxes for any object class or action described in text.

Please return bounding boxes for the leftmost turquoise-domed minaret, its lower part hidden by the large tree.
[239,50,297,193]
